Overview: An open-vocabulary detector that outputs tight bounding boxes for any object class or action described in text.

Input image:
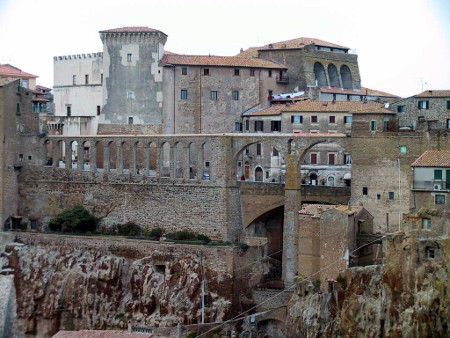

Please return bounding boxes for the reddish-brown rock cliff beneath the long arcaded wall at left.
[7,234,233,337]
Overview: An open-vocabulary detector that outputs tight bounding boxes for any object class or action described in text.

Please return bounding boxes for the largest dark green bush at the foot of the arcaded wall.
[48,205,99,233]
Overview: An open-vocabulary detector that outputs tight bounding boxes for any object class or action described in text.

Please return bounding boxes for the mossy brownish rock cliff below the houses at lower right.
[287,235,450,337]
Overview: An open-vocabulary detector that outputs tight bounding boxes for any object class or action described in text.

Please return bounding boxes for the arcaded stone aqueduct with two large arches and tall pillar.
[27,133,351,286]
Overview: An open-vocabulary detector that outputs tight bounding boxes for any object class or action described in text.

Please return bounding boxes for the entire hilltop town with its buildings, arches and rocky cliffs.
[0,27,450,337]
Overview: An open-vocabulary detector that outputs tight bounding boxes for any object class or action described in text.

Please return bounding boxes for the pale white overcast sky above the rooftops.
[0,0,450,96]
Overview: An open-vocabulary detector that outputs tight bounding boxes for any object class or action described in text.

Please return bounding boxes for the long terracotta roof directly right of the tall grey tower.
[162,54,286,69]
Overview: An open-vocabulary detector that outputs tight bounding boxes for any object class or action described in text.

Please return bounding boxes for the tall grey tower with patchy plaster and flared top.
[98,27,167,134]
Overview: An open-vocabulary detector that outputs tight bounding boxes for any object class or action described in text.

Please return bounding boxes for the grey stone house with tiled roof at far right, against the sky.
[390,90,450,130]
